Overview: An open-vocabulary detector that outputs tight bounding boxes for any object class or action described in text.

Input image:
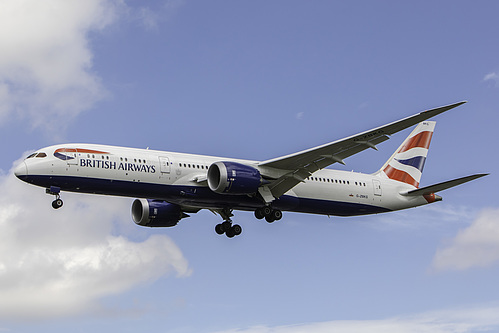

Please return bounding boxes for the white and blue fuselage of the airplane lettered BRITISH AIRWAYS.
[15,144,428,216]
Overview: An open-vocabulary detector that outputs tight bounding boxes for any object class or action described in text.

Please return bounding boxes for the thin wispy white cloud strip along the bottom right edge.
[213,306,499,333]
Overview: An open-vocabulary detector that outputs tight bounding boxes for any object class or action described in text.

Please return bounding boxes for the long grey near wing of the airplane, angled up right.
[258,101,466,202]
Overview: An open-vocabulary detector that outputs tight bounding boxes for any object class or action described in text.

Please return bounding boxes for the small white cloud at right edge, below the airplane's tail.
[432,209,499,271]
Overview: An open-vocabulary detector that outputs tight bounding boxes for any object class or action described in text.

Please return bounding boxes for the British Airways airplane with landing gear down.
[14,101,487,238]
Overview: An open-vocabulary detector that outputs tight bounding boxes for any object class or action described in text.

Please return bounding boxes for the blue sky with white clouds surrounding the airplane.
[0,0,499,333]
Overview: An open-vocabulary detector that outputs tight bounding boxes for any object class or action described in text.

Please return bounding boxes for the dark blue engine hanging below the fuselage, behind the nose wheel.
[132,199,189,227]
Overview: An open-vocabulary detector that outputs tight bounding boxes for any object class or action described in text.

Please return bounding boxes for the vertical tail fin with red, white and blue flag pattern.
[376,121,436,188]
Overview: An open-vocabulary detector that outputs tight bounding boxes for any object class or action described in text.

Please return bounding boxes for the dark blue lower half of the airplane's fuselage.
[20,175,389,216]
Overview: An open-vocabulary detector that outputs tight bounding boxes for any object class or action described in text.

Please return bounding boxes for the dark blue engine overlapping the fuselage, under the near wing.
[208,162,262,194]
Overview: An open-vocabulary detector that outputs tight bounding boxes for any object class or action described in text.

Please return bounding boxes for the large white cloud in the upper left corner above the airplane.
[0,0,120,132]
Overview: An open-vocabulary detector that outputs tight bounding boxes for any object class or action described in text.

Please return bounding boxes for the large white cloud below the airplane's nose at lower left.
[0,158,190,319]
